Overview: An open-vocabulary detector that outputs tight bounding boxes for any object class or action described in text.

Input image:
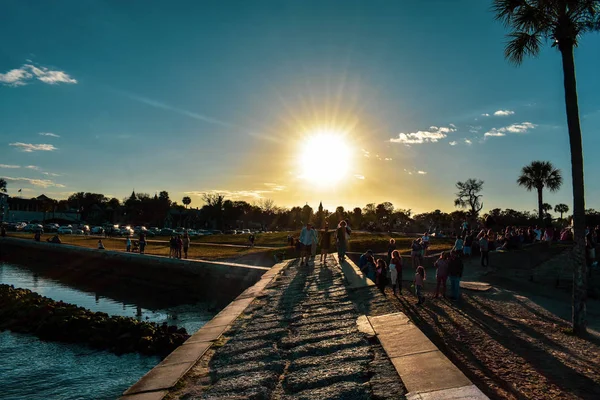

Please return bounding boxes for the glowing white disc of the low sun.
[298,130,352,187]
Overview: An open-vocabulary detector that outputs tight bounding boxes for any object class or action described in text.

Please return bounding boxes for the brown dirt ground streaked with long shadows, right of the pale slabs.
[387,276,600,400]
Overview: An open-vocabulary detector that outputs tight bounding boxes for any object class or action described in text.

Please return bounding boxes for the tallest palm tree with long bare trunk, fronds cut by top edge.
[493,0,600,333]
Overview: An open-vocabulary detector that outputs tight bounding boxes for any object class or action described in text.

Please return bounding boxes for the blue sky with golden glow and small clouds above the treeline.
[0,0,600,216]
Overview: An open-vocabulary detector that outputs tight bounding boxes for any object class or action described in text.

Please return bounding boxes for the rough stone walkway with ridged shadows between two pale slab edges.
[183,258,405,400]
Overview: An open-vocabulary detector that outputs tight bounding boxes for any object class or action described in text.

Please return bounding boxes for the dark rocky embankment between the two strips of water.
[0,285,189,357]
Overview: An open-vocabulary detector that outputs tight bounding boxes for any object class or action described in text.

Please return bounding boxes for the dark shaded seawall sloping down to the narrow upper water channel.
[0,238,269,307]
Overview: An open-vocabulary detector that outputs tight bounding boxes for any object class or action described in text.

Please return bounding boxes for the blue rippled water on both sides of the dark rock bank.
[0,264,213,400]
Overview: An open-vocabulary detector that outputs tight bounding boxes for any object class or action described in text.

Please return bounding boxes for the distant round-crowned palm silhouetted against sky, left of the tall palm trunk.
[517,161,562,222]
